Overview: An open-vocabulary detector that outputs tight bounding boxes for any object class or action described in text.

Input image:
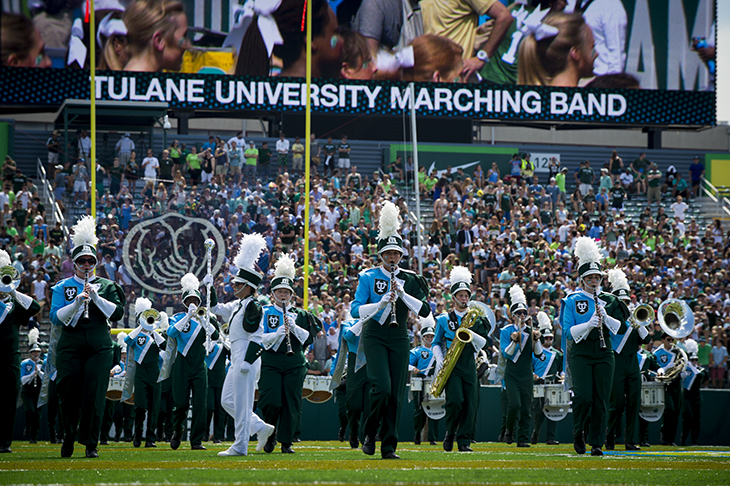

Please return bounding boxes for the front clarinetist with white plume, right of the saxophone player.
[560,236,628,456]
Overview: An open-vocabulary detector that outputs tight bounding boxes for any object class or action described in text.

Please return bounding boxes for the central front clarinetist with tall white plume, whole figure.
[350,201,431,459]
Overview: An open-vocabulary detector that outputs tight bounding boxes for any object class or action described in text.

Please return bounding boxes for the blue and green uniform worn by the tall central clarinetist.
[350,266,431,454]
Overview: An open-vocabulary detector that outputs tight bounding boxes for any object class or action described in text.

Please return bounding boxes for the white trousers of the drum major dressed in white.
[221,341,266,454]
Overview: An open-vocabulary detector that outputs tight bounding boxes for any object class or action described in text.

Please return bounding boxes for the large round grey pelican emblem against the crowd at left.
[122,213,225,294]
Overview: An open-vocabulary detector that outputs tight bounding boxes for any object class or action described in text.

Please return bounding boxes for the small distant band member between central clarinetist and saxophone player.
[408,314,439,445]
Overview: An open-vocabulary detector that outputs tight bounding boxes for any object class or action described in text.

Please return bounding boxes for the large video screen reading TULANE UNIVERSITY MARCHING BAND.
[0,0,716,126]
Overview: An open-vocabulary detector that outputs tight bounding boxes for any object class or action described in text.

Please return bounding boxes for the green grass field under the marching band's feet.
[0,442,730,486]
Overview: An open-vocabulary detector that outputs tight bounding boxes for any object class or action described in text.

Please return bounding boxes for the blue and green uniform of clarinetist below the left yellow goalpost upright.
[51,276,126,448]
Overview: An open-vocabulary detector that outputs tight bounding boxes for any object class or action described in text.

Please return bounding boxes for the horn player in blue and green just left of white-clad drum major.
[167,273,218,451]
